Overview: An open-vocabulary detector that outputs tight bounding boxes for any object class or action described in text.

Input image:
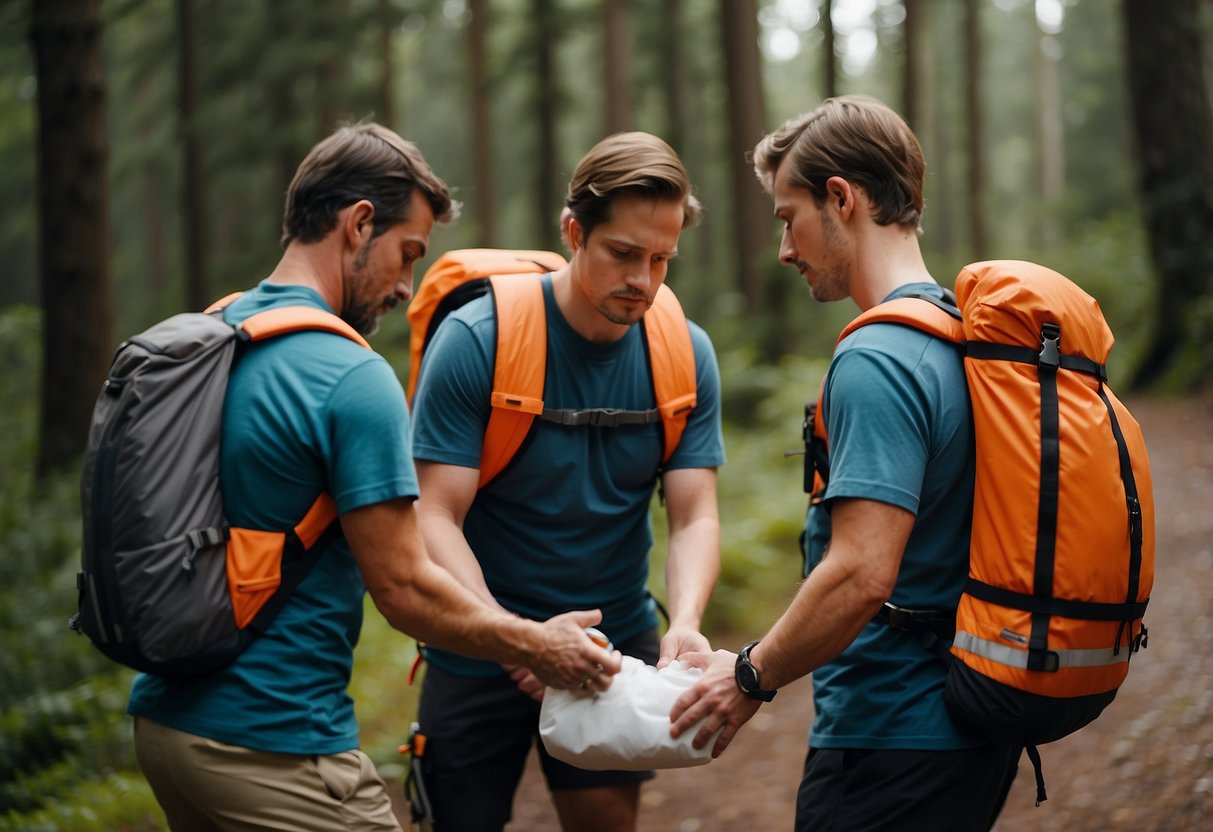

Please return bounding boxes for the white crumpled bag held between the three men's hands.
[539,656,719,771]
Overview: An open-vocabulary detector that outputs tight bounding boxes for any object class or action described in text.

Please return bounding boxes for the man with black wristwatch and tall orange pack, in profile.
[671,96,1019,832]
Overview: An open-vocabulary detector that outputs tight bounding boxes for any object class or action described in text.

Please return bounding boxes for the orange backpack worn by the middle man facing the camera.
[408,249,697,488]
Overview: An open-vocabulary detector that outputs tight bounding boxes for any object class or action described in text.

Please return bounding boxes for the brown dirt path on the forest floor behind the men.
[393,398,1213,832]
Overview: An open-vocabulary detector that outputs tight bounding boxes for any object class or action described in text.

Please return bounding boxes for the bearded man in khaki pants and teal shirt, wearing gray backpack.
[129,124,619,831]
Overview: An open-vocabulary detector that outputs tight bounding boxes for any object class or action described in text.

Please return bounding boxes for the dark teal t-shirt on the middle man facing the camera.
[412,275,724,676]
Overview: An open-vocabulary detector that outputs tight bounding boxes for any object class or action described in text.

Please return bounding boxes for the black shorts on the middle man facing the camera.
[417,631,660,832]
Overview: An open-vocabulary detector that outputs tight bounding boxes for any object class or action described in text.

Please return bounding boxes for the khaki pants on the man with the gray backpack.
[135,717,400,832]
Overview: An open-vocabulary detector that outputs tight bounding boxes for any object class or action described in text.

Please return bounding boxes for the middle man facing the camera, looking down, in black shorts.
[414,133,724,832]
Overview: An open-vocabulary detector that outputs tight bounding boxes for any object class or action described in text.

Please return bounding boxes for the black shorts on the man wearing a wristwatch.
[796,745,1020,832]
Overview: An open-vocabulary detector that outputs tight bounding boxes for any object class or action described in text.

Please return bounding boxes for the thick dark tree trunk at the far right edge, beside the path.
[1122,0,1213,387]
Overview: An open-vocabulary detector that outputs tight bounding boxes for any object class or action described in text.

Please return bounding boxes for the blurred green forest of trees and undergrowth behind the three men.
[0,0,1213,830]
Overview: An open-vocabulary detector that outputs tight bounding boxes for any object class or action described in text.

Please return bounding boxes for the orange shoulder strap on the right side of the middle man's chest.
[640,284,699,463]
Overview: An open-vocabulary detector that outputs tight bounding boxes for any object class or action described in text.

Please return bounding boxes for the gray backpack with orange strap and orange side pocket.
[69,303,370,677]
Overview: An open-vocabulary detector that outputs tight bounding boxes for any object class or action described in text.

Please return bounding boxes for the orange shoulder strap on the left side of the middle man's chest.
[479,274,547,488]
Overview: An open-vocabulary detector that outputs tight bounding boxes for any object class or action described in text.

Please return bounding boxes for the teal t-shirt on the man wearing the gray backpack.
[127,283,417,754]
